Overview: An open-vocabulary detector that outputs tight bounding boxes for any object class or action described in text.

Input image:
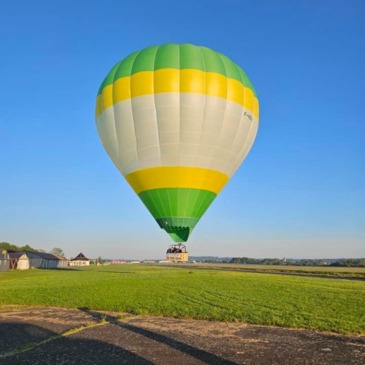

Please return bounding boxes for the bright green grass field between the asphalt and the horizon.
[0,265,365,334]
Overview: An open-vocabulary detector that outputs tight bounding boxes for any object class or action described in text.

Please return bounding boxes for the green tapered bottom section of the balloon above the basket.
[138,188,217,242]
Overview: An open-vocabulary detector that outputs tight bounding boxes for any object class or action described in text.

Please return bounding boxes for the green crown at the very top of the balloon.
[98,44,257,96]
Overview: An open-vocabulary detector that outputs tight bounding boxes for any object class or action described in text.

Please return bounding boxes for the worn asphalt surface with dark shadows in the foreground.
[0,307,365,365]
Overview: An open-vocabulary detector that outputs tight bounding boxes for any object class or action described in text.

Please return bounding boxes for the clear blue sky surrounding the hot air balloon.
[0,0,365,259]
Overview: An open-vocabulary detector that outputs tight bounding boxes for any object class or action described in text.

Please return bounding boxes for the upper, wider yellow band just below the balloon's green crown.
[96,69,259,118]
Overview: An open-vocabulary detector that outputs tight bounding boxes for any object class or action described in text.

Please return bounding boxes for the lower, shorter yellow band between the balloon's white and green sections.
[126,166,229,194]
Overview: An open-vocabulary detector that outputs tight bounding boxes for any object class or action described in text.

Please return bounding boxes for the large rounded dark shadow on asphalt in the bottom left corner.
[0,322,153,365]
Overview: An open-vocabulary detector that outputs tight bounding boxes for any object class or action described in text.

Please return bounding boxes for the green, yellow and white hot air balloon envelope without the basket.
[96,44,259,243]
